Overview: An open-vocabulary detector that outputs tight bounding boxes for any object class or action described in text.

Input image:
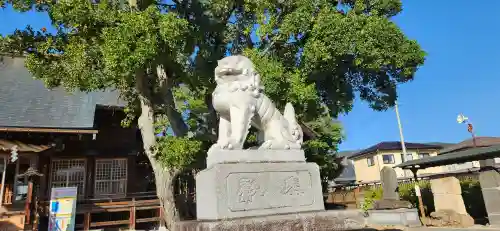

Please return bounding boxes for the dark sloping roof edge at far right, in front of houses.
[394,145,500,169]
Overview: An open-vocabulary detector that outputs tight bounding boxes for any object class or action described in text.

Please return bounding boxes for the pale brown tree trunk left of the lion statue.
[137,74,179,230]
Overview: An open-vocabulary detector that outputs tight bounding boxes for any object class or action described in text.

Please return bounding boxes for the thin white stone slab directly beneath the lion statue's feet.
[207,149,306,168]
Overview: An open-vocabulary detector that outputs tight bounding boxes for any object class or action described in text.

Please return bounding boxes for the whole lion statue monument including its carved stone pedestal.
[177,55,364,230]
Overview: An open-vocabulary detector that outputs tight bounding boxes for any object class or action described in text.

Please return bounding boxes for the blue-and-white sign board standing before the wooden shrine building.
[49,187,78,231]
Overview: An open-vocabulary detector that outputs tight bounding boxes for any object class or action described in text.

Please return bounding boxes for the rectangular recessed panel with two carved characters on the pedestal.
[226,171,312,211]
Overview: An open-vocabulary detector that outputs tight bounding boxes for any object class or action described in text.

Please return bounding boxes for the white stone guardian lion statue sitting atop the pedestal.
[209,55,303,154]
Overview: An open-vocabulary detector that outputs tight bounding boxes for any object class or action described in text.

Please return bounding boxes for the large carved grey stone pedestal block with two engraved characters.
[196,162,324,220]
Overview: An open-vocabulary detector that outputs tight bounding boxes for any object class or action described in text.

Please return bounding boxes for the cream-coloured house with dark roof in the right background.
[349,141,449,183]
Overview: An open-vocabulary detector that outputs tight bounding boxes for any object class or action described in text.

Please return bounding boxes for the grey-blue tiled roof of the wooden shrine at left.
[0,57,125,129]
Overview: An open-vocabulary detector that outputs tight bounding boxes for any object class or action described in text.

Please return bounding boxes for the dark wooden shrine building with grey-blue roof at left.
[0,57,161,230]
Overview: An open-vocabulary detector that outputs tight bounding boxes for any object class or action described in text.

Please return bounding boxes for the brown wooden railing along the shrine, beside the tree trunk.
[39,192,163,230]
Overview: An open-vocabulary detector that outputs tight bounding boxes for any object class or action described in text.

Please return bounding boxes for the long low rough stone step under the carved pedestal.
[175,210,366,231]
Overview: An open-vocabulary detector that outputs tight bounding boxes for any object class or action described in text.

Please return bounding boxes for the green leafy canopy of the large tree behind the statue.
[0,0,425,182]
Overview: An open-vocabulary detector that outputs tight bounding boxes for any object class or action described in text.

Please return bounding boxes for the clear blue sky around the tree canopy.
[0,0,500,151]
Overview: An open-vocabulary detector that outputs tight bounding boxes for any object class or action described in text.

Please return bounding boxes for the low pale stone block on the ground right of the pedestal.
[367,209,422,227]
